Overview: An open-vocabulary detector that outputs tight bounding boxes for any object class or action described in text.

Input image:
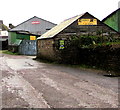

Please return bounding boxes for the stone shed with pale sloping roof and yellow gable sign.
[37,12,119,62]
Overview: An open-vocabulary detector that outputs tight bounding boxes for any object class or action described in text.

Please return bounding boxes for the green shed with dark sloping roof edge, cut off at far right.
[102,8,120,33]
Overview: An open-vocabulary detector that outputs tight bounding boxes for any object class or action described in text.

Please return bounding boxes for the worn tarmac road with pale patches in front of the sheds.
[0,54,118,108]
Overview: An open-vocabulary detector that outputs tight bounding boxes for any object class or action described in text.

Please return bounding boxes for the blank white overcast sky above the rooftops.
[0,0,120,26]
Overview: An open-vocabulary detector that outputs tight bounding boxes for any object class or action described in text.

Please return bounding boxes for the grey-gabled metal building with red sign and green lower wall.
[8,16,56,55]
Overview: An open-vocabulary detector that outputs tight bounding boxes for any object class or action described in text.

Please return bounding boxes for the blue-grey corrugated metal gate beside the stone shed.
[19,40,37,55]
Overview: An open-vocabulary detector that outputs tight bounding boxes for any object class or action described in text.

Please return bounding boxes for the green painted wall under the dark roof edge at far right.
[104,10,120,32]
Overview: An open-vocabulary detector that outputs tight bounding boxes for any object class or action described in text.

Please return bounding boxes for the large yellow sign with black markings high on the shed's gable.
[78,19,97,25]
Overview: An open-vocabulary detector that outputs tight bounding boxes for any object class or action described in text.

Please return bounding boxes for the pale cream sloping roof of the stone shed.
[37,14,84,39]
